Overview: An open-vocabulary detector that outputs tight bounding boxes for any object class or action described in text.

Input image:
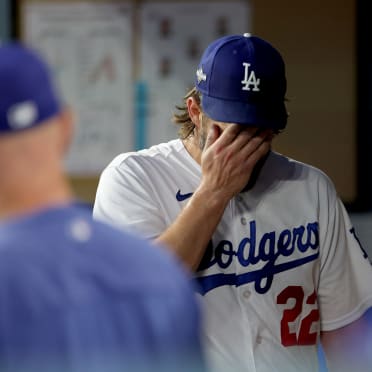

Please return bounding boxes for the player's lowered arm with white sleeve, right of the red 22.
[318,179,372,372]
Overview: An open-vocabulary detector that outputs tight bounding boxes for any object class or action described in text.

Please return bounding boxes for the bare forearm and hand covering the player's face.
[156,124,272,270]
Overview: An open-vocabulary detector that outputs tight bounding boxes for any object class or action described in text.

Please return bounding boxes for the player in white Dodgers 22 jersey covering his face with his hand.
[94,34,372,372]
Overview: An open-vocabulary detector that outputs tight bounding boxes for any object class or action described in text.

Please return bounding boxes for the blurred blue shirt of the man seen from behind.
[0,205,204,372]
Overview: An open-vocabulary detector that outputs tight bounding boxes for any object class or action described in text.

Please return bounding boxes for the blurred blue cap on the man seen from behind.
[0,42,61,135]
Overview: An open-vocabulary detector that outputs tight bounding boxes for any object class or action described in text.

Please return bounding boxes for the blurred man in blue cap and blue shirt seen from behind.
[0,43,204,372]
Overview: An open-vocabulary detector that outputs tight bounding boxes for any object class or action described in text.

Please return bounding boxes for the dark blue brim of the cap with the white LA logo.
[201,94,288,130]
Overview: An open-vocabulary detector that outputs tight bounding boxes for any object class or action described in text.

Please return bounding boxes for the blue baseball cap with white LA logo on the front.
[195,33,288,130]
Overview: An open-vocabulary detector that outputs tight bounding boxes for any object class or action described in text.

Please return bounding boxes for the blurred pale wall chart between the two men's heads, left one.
[21,1,133,176]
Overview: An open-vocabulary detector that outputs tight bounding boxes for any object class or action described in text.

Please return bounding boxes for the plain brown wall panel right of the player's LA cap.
[252,0,356,202]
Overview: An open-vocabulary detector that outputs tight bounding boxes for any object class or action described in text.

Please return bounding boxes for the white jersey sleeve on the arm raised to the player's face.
[93,159,165,239]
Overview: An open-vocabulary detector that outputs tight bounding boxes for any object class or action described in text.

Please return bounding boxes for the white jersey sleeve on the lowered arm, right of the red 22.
[318,178,372,331]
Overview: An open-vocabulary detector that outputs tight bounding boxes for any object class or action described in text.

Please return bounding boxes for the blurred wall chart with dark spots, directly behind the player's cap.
[140,1,251,145]
